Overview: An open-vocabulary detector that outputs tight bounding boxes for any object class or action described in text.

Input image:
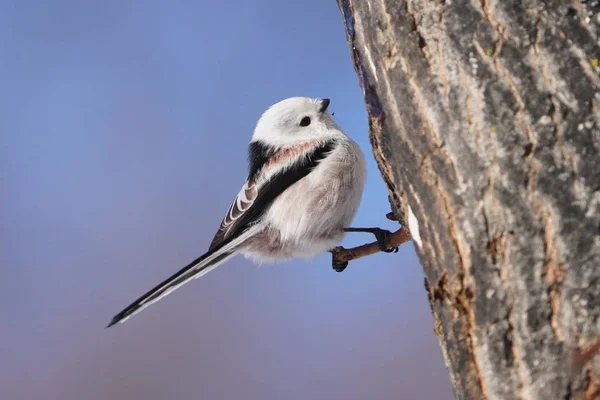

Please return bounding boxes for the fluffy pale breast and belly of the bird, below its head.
[264,137,366,258]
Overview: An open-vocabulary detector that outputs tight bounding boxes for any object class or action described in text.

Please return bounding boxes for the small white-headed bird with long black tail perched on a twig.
[108,97,366,326]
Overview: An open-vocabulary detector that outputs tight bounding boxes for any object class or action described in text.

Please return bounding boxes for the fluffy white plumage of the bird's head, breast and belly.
[240,97,366,261]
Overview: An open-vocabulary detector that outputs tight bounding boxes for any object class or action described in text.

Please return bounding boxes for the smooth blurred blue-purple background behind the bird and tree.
[0,0,452,400]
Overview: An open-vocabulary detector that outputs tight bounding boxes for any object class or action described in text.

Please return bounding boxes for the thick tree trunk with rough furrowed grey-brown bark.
[338,0,600,399]
